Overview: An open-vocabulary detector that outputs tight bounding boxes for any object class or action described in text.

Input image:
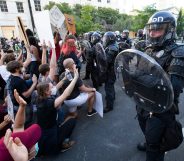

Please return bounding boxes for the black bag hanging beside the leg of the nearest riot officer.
[160,120,183,152]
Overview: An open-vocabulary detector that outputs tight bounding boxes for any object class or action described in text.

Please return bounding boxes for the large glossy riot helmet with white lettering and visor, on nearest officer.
[146,11,176,47]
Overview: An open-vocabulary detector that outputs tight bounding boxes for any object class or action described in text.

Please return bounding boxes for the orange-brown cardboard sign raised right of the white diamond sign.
[64,14,76,34]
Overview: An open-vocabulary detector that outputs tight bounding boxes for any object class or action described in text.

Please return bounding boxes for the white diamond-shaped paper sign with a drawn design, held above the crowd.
[49,6,65,29]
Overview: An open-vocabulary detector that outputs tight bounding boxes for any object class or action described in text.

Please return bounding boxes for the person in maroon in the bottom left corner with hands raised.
[0,90,41,161]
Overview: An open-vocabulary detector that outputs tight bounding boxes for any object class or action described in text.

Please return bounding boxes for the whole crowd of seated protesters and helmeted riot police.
[0,11,184,161]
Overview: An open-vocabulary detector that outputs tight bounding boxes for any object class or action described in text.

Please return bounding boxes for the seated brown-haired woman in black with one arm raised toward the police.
[37,67,78,155]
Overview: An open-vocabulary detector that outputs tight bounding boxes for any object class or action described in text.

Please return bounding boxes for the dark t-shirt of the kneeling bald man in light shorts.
[62,74,83,100]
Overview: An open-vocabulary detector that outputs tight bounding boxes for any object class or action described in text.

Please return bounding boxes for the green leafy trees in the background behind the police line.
[44,2,160,34]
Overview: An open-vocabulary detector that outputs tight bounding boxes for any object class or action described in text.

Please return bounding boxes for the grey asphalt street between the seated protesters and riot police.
[36,72,184,161]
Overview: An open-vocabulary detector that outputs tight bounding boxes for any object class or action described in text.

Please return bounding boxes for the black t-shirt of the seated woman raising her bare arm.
[37,97,57,129]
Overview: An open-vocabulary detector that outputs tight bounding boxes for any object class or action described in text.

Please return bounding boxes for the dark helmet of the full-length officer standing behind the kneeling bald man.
[103,31,116,47]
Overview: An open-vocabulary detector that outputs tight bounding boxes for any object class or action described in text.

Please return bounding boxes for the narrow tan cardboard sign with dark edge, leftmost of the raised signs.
[17,17,29,45]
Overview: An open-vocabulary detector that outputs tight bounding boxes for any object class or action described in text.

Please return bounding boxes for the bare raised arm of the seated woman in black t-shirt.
[54,69,79,108]
